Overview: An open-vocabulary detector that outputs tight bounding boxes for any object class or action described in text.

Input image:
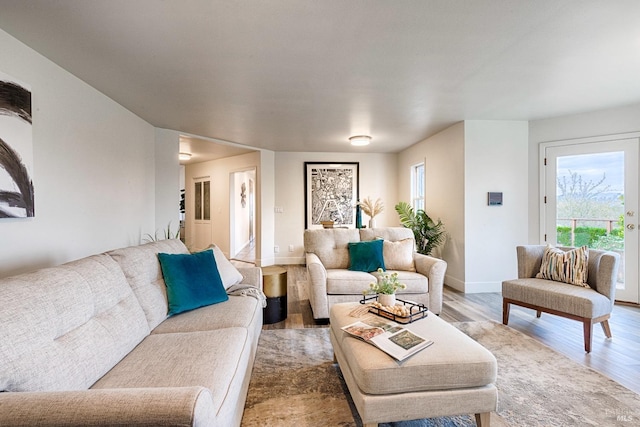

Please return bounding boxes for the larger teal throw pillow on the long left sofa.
[158,249,229,316]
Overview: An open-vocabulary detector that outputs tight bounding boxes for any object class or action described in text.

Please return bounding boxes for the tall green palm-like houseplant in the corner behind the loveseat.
[395,202,446,255]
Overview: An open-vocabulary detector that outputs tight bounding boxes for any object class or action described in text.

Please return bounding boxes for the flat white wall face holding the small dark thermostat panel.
[464,120,528,292]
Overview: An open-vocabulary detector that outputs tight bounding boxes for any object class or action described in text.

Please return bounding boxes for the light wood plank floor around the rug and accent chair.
[238,263,640,393]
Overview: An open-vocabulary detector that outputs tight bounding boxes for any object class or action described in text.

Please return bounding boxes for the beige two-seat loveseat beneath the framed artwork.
[304,227,447,319]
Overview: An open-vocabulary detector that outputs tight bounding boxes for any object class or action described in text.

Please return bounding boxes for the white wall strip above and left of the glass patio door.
[528,104,640,244]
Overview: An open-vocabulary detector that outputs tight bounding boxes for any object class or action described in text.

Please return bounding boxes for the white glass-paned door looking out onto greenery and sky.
[542,138,640,304]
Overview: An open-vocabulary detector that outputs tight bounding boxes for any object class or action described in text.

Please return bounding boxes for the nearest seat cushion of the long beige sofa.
[91,328,252,425]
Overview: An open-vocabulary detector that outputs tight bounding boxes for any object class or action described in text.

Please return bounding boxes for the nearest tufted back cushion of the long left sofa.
[0,254,150,391]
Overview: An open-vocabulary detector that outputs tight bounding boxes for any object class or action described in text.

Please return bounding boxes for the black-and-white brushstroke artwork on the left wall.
[0,73,35,218]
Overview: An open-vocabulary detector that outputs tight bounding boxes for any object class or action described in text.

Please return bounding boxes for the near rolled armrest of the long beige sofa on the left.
[0,387,216,426]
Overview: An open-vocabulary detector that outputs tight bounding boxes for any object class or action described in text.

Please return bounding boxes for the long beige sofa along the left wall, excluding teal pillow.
[0,240,262,426]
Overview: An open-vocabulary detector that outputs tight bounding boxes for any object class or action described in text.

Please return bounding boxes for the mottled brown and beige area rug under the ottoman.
[242,321,640,427]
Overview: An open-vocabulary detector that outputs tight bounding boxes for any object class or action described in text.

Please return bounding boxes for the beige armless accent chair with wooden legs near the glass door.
[502,245,620,353]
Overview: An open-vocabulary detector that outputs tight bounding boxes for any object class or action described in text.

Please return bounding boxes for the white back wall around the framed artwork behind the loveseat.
[274,152,399,264]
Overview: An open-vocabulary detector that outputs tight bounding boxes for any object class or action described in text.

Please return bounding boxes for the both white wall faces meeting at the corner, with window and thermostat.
[398,120,528,292]
